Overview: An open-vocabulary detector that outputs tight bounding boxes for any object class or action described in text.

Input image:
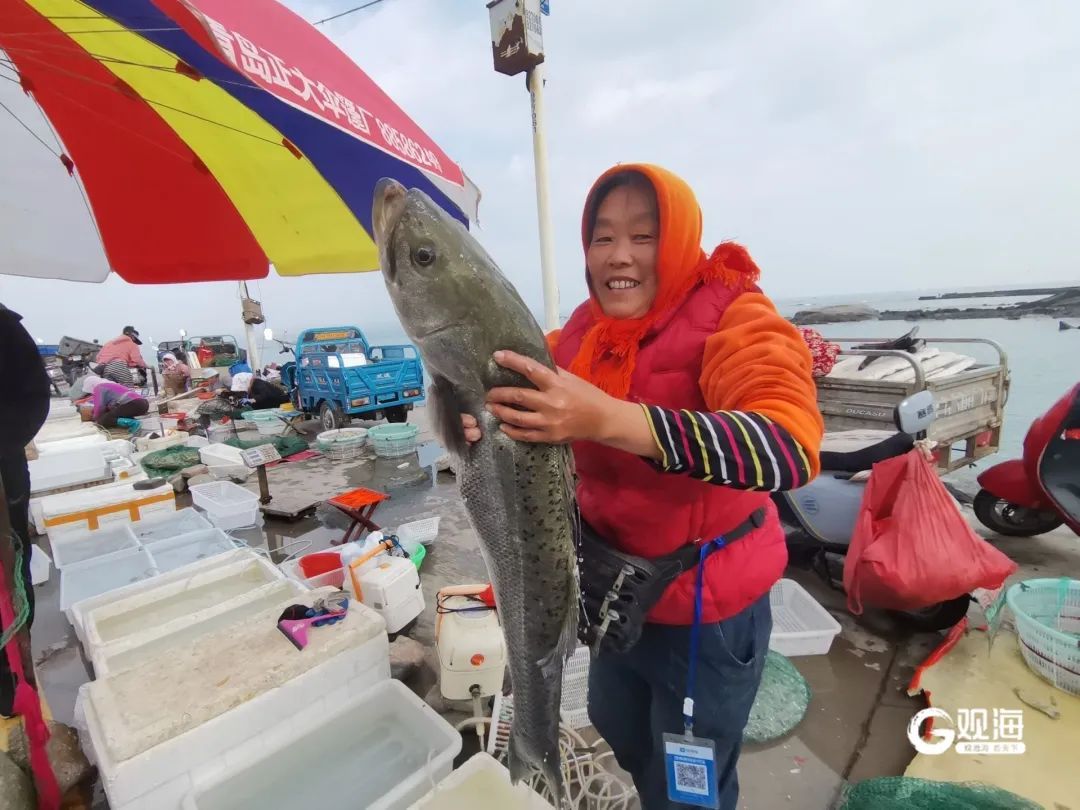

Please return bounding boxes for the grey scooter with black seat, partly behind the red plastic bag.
[773,391,971,631]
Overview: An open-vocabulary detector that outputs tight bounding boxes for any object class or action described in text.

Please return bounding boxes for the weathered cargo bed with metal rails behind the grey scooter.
[816,338,1009,474]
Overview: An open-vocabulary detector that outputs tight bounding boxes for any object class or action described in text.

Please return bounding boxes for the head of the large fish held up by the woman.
[372,178,490,349]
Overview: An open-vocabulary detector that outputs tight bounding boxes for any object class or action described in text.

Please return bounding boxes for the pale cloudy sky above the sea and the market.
[0,0,1080,352]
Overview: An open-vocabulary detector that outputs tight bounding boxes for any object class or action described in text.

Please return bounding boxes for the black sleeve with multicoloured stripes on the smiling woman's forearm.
[642,405,813,492]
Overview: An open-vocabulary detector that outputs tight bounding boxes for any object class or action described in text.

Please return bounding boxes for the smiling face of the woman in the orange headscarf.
[585,178,660,319]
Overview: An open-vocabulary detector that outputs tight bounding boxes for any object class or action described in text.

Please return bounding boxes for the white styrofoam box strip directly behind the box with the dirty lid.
[87,579,306,678]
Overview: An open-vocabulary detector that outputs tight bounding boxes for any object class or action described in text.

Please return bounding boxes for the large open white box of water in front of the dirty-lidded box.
[184,680,461,810]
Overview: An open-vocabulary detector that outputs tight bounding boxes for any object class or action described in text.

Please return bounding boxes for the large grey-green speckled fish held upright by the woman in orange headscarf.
[372,179,579,796]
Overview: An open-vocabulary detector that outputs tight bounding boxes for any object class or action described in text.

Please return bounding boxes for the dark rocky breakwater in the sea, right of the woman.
[792,287,1080,326]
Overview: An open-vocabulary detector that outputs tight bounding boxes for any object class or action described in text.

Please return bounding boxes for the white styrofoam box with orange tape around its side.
[41,483,176,540]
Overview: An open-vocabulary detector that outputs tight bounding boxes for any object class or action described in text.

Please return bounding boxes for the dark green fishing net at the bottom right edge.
[837,777,1042,810]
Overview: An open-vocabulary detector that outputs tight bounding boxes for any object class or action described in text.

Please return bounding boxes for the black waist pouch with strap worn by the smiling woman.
[578,509,765,654]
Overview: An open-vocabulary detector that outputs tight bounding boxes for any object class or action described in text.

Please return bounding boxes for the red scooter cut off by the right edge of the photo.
[973,384,1080,537]
